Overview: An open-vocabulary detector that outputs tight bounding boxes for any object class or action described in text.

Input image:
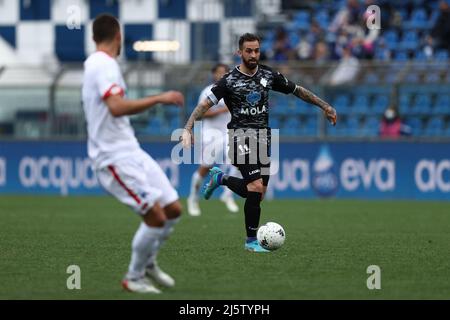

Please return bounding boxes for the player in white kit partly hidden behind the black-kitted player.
[187,63,239,216]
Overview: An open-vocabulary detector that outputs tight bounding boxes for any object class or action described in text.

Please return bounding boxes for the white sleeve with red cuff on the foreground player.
[95,64,125,100]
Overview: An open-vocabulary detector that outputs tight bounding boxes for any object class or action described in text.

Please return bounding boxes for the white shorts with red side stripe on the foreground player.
[96,151,179,215]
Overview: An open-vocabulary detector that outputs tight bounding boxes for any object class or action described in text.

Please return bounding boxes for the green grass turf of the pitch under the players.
[0,196,450,300]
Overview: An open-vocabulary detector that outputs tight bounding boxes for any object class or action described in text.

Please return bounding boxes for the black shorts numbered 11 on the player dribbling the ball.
[228,129,270,187]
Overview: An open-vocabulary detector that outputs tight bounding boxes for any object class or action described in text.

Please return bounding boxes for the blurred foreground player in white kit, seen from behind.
[82,14,184,293]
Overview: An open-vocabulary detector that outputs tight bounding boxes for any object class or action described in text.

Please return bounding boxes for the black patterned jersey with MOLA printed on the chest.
[208,65,295,129]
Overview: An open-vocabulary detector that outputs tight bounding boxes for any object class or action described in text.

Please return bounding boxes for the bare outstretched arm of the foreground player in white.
[104,91,184,117]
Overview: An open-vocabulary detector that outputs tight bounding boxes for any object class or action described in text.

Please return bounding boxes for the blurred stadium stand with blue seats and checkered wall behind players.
[0,0,450,138]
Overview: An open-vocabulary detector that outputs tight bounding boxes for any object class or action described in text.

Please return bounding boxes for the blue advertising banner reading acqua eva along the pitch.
[0,141,450,200]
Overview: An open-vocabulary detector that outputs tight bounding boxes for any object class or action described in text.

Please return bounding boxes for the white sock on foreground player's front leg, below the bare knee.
[126,222,164,279]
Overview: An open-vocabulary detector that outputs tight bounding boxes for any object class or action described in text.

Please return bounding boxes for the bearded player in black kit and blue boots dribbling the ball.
[182,33,337,252]
